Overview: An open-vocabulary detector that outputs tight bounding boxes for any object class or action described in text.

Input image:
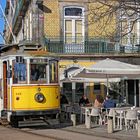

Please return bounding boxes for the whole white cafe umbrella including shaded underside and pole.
[73,58,140,94]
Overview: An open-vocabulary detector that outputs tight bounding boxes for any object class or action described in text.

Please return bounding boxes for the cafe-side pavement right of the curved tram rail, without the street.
[20,122,140,140]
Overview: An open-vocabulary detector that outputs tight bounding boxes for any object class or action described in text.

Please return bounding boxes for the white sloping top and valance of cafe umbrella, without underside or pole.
[86,58,140,75]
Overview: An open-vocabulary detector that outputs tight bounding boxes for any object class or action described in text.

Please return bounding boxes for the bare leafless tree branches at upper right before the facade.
[88,0,140,41]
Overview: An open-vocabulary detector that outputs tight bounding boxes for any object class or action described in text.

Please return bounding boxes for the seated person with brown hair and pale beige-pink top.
[94,95,104,108]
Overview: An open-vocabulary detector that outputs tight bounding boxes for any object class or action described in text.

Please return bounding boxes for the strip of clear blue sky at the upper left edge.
[0,0,6,44]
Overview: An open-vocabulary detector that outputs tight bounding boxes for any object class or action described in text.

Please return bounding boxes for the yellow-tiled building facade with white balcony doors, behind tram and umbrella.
[4,0,139,106]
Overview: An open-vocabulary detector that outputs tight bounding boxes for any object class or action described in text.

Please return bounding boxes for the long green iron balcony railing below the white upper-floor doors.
[45,37,140,55]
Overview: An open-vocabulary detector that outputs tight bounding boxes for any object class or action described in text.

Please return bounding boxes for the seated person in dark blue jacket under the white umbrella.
[103,95,116,108]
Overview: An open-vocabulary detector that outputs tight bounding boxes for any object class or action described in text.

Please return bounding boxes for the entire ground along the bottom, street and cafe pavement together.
[0,123,140,140]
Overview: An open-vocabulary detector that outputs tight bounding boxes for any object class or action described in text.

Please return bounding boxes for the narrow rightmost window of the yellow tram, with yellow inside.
[50,61,58,83]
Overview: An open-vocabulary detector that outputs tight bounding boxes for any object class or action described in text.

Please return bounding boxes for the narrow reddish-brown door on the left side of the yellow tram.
[3,62,7,109]
